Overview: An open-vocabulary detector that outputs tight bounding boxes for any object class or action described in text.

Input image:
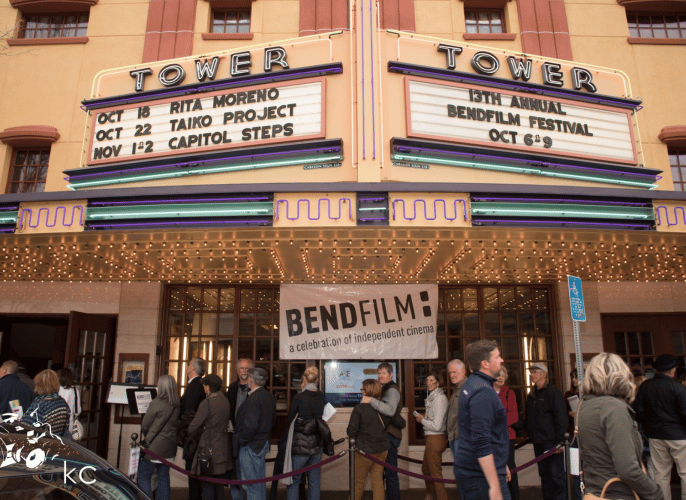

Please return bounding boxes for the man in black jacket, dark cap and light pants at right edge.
[635,354,686,500]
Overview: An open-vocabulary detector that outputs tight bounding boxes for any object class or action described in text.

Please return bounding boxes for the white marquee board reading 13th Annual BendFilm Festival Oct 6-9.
[405,76,637,165]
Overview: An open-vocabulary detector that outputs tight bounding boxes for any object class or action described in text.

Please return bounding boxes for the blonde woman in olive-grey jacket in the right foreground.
[578,352,664,500]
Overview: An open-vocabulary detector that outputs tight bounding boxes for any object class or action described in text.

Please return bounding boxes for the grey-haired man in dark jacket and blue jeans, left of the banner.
[233,368,276,500]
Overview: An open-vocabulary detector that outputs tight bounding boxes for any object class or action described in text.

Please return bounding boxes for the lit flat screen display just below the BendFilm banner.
[323,361,399,408]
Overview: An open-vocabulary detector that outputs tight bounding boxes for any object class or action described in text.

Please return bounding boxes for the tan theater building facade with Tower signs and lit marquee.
[0,0,686,489]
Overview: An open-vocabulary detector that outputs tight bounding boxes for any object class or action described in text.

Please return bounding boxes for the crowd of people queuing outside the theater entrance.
[5,346,686,500]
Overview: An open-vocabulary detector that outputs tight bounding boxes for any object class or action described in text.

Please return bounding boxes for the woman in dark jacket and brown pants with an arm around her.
[347,378,390,500]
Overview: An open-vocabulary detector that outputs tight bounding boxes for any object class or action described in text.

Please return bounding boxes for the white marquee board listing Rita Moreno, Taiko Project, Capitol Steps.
[87,78,326,165]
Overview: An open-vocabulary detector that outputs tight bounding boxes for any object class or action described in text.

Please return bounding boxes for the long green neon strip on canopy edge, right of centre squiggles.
[471,195,655,230]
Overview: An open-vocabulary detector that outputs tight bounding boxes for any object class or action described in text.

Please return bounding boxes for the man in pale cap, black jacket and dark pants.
[526,363,569,500]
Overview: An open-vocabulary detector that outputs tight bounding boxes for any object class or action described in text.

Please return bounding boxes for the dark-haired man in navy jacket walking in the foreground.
[455,340,510,500]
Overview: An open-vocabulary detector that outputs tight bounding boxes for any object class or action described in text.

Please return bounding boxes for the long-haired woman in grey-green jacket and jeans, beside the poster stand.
[138,375,181,500]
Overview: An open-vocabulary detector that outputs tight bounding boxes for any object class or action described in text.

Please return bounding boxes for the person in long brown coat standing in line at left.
[188,375,233,500]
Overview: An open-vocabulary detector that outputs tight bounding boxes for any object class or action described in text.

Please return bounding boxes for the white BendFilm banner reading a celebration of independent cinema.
[279,284,438,359]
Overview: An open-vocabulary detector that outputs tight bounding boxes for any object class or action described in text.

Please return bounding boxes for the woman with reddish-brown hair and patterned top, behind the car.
[21,370,70,436]
